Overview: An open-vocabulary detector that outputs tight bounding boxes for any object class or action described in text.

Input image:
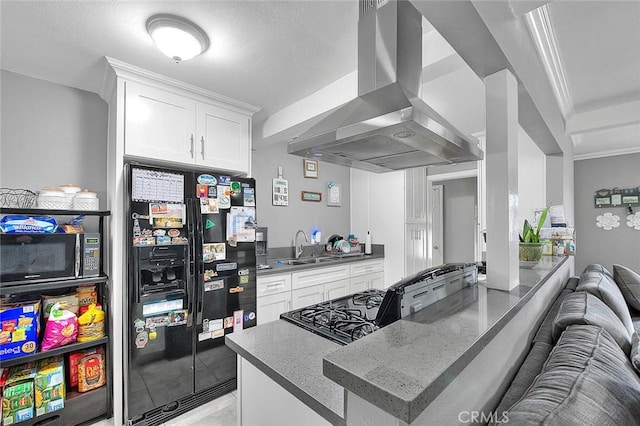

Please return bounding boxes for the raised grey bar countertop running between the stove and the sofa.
[323,258,564,423]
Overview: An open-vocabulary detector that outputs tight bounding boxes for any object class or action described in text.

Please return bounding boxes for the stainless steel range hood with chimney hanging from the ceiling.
[288,0,482,172]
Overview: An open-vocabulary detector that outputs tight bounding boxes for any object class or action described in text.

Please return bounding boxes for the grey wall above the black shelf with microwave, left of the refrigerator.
[0,71,108,208]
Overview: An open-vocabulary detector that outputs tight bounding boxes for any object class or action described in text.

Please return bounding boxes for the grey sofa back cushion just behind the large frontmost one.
[551,291,631,356]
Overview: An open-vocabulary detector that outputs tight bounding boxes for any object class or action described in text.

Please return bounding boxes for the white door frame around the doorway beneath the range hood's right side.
[426,168,484,267]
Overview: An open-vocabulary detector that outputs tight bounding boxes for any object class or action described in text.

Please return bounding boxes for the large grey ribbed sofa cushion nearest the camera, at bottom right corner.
[506,325,640,426]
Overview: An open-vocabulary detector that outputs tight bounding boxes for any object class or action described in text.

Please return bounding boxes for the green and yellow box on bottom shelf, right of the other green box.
[35,356,65,416]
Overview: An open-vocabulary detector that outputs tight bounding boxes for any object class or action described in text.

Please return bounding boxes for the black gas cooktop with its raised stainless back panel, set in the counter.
[280,263,478,345]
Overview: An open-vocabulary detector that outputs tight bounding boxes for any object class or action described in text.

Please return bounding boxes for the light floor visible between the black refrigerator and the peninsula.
[91,391,237,426]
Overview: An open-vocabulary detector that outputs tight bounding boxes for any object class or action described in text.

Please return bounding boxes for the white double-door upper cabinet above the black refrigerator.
[112,59,259,175]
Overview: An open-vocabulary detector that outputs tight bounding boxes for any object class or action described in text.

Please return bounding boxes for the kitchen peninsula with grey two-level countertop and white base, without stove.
[226,258,573,425]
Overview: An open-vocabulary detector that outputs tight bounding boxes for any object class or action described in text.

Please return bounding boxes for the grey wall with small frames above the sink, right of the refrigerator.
[252,141,350,247]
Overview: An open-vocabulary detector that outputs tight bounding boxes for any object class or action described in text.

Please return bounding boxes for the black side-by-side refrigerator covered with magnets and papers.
[125,163,256,425]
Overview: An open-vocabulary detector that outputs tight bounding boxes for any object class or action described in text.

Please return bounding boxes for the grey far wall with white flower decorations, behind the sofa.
[574,153,640,273]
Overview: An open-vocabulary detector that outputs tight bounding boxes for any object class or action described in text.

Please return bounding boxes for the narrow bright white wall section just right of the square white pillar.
[516,127,544,233]
